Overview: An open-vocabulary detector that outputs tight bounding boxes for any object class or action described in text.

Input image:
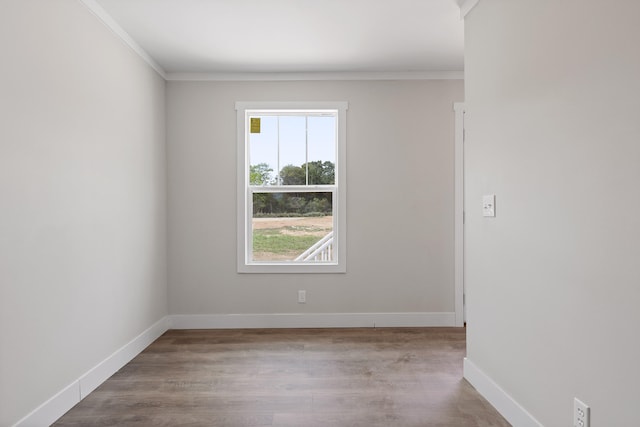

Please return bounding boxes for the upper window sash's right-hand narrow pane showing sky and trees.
[307,116,336,185]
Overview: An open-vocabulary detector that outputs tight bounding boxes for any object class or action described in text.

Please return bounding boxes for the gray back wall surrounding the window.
[167,80,463,314]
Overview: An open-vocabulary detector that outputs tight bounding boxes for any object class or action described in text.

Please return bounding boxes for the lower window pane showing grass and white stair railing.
[251,192,334,262]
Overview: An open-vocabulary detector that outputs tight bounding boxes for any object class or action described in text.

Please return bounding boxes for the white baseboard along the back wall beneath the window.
[169,312,456,329]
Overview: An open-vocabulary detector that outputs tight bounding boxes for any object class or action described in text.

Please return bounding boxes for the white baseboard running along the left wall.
[13,316,169,427]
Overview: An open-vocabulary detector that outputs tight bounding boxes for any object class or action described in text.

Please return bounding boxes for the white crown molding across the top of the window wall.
[165,70,464,81]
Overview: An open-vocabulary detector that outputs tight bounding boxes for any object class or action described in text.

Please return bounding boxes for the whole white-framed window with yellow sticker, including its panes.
[236,102,347,273]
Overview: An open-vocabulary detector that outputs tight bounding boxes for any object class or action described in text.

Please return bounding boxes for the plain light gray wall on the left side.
[0,0,167,426]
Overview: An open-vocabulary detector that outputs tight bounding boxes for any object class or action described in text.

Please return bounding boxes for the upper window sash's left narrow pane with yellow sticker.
[249,116,278,185]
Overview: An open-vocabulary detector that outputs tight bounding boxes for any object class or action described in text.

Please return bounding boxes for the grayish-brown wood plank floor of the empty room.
[54,328,510,427]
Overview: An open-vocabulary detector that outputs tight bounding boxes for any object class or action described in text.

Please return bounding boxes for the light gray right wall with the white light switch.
[465,0,640,427]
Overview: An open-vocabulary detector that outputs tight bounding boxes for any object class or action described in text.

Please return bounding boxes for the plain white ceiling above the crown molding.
[90,0,464,74]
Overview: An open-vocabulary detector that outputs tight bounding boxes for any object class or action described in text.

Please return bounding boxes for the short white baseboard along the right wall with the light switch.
[464,357,544,427]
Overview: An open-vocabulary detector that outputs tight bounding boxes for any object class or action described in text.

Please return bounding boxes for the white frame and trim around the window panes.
[236,101,348,273]
